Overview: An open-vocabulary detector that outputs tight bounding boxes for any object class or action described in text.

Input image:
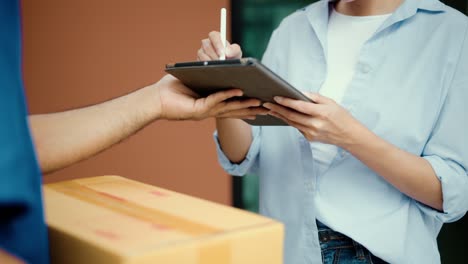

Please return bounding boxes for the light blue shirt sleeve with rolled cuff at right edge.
[421,21,468,222]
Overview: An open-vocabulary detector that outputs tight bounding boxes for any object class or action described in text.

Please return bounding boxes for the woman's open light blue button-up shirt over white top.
[215,0,468,264]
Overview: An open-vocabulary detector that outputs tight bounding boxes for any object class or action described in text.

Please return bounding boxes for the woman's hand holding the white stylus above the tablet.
[197,31,242,61]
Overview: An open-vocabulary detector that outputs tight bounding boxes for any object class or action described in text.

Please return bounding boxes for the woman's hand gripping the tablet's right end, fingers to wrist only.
[263,93,364,149]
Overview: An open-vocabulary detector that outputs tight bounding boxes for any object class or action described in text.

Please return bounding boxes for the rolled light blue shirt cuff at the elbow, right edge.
[419,155,468,223]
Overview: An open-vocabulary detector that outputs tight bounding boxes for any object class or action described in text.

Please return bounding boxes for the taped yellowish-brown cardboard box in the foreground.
[44,176,284,264]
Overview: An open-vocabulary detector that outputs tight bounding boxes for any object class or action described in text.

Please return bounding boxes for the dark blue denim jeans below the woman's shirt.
[317,221,387,264]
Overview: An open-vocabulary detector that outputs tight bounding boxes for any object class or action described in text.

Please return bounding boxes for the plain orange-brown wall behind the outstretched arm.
[22,0,231,203]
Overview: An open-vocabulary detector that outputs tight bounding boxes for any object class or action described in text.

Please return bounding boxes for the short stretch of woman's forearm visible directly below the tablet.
[216,118,252,163]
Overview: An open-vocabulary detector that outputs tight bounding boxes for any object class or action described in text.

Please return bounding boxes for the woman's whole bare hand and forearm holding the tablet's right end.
[264,94,444,211]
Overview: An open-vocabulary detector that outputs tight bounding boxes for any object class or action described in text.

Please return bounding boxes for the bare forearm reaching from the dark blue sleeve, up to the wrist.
[29,85,159,173]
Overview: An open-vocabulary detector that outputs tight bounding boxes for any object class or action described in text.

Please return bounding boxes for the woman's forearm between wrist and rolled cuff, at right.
[342,126,443,211]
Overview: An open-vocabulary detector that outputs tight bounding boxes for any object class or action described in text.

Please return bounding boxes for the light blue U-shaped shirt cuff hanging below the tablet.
[213,126,260,176]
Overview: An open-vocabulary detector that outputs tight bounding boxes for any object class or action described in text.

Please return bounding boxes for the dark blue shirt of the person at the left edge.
[0,0,49,263]
